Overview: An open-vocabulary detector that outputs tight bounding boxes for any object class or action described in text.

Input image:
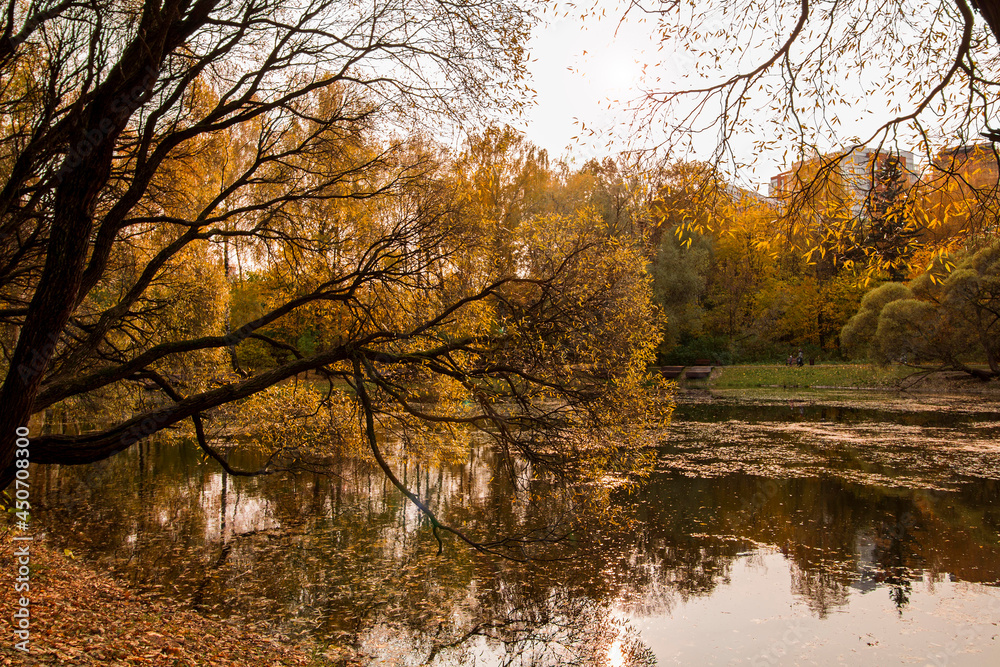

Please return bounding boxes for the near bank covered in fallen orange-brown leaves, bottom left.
[0,529,330,667]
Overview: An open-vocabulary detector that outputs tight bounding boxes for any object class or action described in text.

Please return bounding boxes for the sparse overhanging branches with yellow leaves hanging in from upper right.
[627,0,1000,272]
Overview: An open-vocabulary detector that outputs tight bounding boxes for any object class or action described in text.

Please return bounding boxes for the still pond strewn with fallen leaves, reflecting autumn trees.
[32,390,1000,667]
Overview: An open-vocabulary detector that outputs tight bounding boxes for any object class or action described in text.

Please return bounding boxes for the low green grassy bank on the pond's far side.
[681,364,1000,396]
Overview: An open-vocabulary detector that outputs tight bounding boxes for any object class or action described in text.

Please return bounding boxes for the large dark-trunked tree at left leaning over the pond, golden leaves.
[0,0,672,548]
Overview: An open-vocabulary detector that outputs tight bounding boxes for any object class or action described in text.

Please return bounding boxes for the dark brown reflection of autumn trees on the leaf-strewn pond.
[27,392,1000,666]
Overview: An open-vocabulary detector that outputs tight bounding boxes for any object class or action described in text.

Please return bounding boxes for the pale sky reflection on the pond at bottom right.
[632,550,1000,666]
